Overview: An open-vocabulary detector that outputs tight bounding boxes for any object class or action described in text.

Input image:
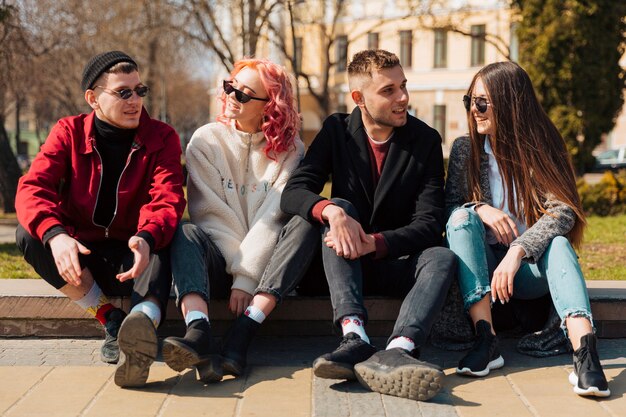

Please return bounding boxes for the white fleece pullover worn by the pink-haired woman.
[186,123,304,294]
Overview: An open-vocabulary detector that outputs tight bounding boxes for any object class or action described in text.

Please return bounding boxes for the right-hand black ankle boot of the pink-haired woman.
[222,314,261,376]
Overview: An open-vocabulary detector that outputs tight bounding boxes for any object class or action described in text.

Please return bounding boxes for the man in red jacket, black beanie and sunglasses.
[16,51,185,387]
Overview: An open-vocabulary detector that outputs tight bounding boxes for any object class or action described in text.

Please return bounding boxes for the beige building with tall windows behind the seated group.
[280,0,516,154]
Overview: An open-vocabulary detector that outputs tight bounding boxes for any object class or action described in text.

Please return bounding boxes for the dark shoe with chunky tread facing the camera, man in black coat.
[354,348,444,401]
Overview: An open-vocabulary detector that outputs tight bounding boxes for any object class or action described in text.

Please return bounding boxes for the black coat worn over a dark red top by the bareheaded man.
[281,107,445,258]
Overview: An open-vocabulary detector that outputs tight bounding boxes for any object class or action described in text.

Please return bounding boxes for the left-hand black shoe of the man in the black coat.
[313,332,378,379]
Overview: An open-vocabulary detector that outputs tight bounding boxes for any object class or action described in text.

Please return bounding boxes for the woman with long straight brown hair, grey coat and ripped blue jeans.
[446,62,610,397]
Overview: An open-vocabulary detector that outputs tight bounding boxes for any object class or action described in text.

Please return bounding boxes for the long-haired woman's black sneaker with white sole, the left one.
[456,320,504,376]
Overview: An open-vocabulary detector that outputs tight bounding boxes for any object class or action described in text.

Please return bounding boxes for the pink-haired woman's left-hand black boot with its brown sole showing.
[163,319,224,382]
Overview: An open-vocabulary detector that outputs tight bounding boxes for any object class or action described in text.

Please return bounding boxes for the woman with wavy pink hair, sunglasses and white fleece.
[163,59,304,382]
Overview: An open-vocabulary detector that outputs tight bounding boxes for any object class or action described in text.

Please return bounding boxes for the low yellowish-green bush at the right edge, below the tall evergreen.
[577,170,626,216]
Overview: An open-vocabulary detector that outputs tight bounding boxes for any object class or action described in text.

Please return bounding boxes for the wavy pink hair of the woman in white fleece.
[217,59,300,159]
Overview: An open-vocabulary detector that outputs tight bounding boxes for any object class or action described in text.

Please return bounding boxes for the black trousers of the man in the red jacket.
[15,225,172,314]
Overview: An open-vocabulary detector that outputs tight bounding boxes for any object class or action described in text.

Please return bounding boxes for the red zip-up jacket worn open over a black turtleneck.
[15,109,185,250]
